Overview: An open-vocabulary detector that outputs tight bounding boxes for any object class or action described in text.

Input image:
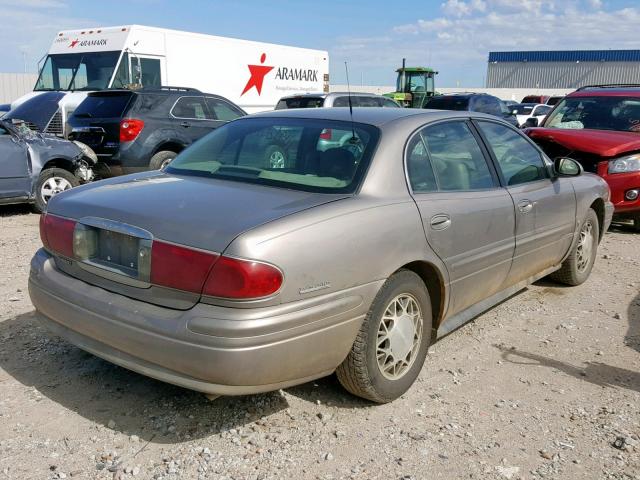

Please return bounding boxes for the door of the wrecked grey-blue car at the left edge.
[0,125,30,198]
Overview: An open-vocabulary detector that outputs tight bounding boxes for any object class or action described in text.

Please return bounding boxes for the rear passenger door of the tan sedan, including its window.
[406,120,515,316]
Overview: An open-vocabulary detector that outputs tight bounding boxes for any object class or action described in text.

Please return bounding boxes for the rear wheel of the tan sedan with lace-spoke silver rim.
[336,270,432,403]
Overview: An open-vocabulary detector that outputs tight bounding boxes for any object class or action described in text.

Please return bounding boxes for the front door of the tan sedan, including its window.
[475,120,576,284]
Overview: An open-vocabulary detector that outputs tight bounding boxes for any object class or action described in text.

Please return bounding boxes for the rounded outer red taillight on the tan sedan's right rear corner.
[202,257,283,299]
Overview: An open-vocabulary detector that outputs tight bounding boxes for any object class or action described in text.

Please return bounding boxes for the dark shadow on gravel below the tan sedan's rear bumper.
[0,312,290,444]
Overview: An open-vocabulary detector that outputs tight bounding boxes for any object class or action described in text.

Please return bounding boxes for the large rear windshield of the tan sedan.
[167,118,380,193]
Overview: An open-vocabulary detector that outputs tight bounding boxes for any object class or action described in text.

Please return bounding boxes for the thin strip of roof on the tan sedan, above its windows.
[245,107,497,127]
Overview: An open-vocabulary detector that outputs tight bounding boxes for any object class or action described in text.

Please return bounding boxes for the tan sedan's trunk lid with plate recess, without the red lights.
[48,172,349,308]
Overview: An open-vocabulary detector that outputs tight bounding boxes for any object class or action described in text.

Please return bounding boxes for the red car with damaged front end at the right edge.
[526,85,640,232]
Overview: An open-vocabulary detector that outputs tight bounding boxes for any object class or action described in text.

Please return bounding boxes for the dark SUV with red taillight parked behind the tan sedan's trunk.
[69,87,246,178]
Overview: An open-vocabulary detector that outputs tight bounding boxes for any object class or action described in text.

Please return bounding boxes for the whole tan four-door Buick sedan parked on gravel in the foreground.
[29,108,612,402]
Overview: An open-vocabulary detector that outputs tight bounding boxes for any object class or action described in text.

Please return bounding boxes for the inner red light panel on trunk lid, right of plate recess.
[151,240,219,293]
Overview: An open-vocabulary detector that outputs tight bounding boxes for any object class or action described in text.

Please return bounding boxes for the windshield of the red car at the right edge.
[544,96,640,132]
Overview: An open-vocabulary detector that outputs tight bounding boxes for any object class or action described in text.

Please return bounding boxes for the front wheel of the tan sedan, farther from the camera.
[550,208,600,286]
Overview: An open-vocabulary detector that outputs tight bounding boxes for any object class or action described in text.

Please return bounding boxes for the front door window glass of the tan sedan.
[478,121,547,186]
